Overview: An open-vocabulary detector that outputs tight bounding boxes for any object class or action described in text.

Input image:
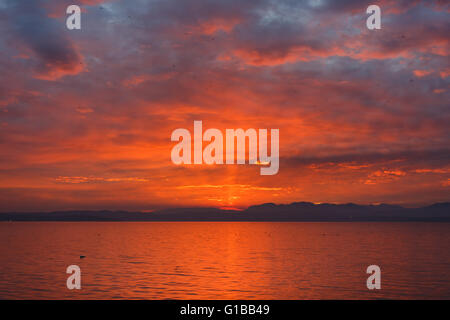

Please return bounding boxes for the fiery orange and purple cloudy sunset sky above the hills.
[0,0,450,212]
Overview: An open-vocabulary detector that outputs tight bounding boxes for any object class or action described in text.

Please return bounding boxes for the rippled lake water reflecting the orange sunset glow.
[0,222,450,299]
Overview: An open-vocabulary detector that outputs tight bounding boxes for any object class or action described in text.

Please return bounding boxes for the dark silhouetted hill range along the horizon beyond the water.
[0,202,450,222]
